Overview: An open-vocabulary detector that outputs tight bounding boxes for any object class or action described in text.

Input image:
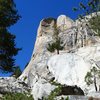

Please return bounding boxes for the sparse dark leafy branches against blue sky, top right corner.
[73,0,100,18]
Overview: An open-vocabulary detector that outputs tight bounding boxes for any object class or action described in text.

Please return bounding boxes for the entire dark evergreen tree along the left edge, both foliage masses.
[0,0,21,72]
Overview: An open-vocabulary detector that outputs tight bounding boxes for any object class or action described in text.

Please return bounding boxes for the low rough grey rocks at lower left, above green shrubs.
[0,77,30,94]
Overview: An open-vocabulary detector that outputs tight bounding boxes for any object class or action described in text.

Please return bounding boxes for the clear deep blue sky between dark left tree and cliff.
[10,0,81,70]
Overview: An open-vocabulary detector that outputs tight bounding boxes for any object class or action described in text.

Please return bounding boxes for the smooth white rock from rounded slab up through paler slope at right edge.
[48,44,100,89]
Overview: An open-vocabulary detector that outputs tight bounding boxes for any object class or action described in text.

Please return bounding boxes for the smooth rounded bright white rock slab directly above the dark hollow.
[48,53,91,87]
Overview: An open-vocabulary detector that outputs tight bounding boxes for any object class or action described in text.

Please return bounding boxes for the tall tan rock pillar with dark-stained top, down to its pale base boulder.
[20,18,56,100]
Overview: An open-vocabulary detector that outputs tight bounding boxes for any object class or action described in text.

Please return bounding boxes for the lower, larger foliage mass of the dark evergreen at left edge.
[0,28,20,72]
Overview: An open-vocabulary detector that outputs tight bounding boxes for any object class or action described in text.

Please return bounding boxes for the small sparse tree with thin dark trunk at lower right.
[85,67,100,91]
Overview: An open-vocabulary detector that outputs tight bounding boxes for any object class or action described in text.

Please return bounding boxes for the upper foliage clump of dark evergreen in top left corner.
[0,0,20,27]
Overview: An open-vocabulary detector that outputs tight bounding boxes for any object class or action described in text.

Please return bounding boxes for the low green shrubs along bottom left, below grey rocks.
[2,93,34,100]
